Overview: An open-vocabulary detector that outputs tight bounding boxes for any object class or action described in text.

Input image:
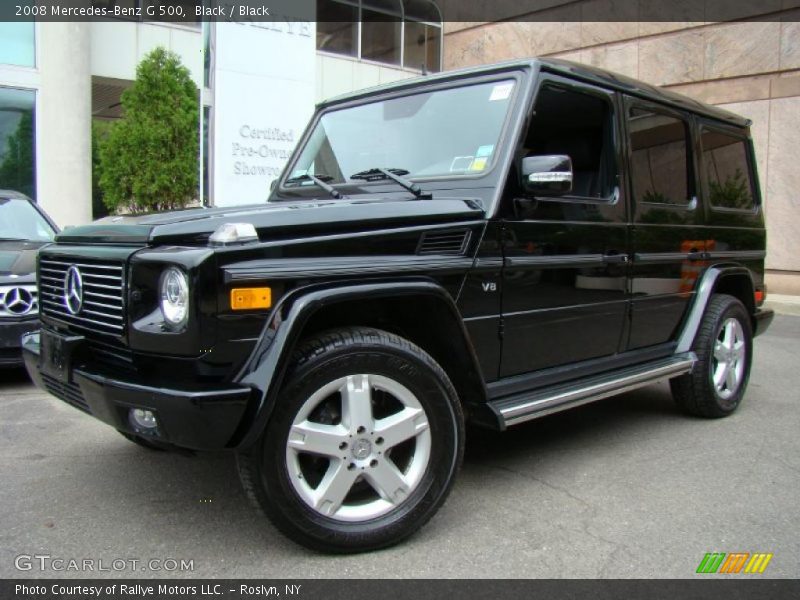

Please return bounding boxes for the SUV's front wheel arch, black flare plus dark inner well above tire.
[230,280,487,448]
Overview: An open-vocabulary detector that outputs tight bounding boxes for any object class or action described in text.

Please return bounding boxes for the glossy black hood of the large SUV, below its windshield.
[56,198,484,245]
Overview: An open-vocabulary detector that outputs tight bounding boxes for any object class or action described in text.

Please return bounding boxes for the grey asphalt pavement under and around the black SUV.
[0,316,800,578]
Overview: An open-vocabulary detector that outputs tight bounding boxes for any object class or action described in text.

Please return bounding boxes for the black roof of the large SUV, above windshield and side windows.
[319,58,751,127]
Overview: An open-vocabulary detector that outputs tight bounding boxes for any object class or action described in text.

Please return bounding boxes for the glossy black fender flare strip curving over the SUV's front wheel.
[230,280,483,449]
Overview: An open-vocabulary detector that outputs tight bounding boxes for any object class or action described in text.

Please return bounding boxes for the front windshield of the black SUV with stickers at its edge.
[287,80,515,186]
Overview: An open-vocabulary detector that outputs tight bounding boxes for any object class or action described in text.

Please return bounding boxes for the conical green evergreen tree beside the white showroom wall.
[99,48,199,213]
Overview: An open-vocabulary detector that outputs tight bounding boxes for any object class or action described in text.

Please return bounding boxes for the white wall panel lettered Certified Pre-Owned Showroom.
[211,22,316,206]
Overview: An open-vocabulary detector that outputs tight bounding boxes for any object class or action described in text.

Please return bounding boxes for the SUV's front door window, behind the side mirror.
[522,84,617,200]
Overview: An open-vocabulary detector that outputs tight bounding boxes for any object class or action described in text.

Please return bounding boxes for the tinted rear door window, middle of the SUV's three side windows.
[628,107,691,206]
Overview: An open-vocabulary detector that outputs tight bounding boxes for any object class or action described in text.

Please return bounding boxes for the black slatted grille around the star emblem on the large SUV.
[39,256,125,336]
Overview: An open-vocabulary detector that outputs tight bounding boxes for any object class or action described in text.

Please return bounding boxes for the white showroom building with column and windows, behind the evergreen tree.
[0,0,443,227]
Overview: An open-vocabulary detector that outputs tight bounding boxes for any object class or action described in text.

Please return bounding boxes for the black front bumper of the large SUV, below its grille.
[22,332,252,450]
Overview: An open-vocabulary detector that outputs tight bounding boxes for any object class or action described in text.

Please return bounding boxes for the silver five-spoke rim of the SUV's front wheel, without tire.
[286,374,431,521]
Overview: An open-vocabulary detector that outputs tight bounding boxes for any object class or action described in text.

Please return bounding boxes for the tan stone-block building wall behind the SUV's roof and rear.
[444,15,800,295]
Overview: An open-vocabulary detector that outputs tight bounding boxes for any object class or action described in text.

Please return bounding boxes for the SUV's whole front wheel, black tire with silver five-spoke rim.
[237,327,464,553]
